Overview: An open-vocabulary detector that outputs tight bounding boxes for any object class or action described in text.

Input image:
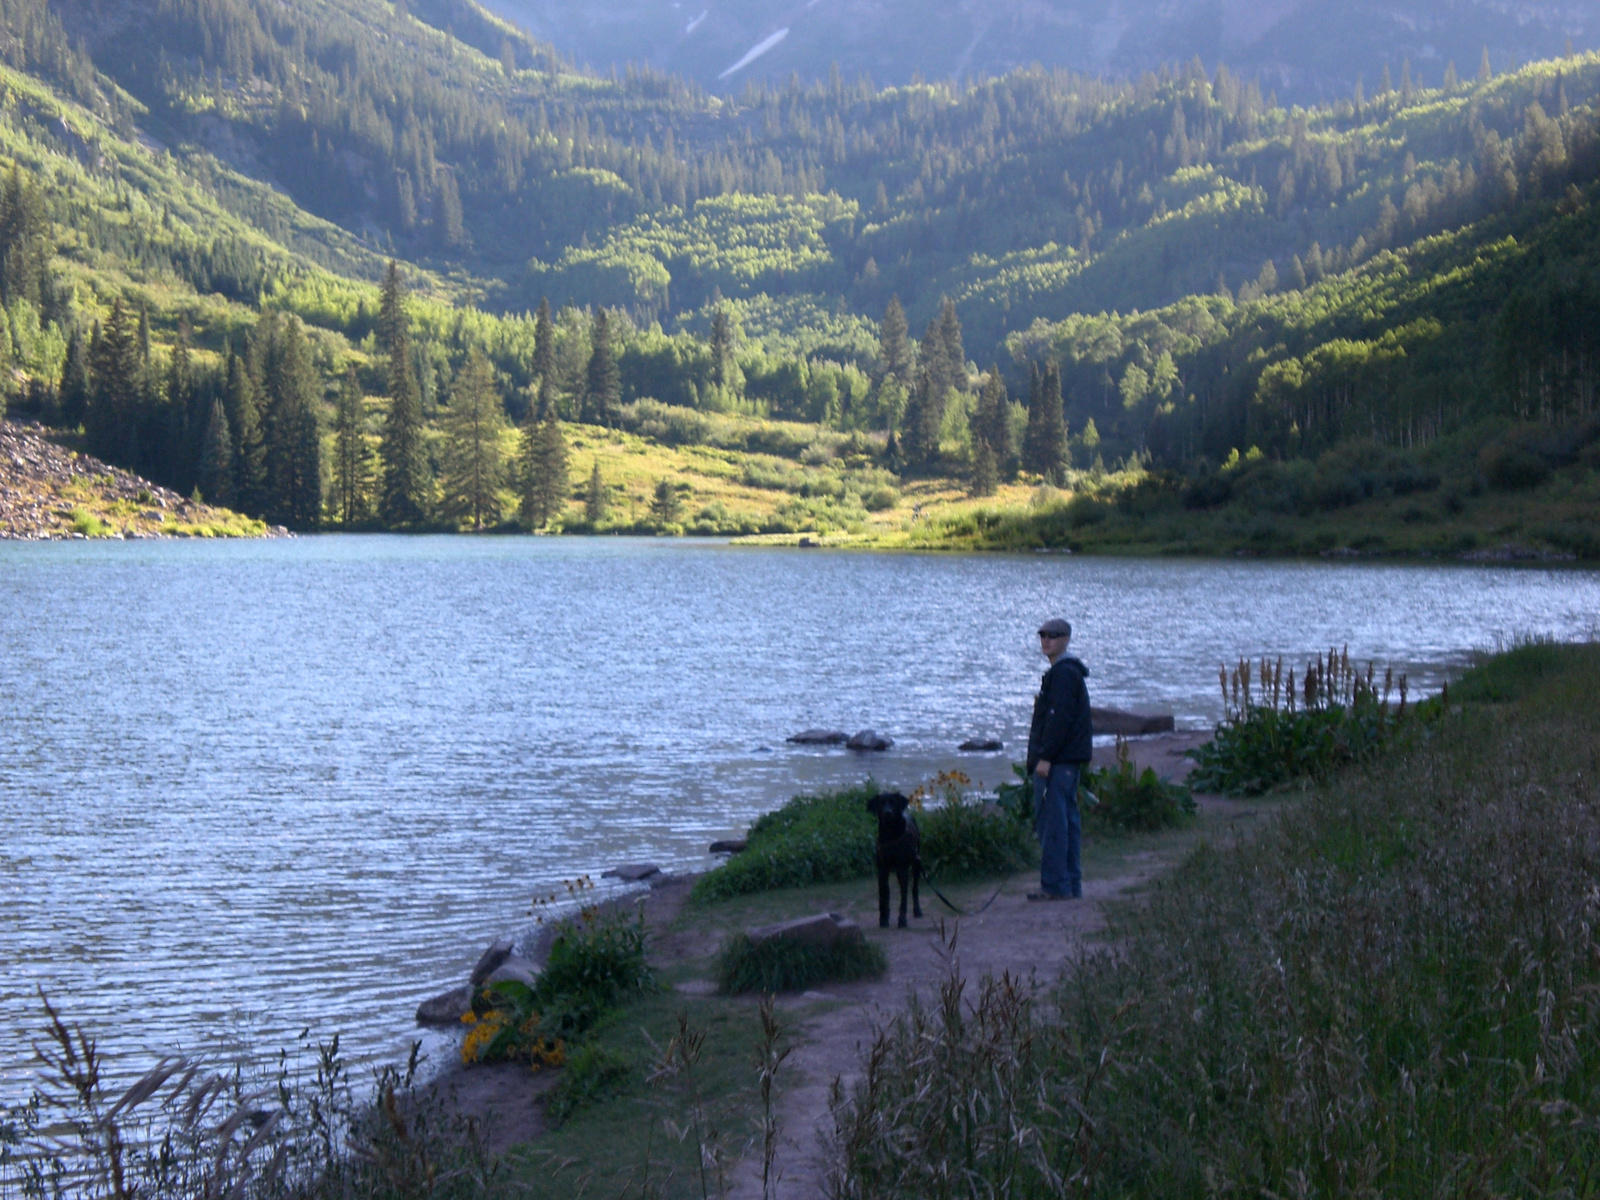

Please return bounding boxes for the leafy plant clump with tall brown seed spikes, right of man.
[1189,646,1408,795]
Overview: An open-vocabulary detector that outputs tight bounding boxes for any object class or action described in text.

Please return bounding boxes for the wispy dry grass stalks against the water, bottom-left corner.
[0,997,499,1200]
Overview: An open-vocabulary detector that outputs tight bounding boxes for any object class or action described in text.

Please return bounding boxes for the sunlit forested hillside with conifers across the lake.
[0,0,1600,556]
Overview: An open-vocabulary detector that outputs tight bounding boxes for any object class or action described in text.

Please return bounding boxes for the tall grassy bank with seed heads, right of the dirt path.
[832,646,1600,1198]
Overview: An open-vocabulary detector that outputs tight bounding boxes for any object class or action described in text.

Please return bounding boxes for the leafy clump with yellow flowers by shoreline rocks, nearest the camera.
[461,883,656,1070]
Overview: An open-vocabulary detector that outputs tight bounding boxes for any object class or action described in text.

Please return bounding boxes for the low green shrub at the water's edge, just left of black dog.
[690,781,878,904]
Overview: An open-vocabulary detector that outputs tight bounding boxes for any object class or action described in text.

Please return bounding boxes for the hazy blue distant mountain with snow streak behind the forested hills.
[490,0,1600,101]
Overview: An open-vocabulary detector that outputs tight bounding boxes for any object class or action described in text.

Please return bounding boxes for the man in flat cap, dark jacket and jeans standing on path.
[1027,618,1094,901]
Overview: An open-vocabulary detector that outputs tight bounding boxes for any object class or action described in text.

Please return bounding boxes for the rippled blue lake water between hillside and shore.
[0,538,1600,1094]
